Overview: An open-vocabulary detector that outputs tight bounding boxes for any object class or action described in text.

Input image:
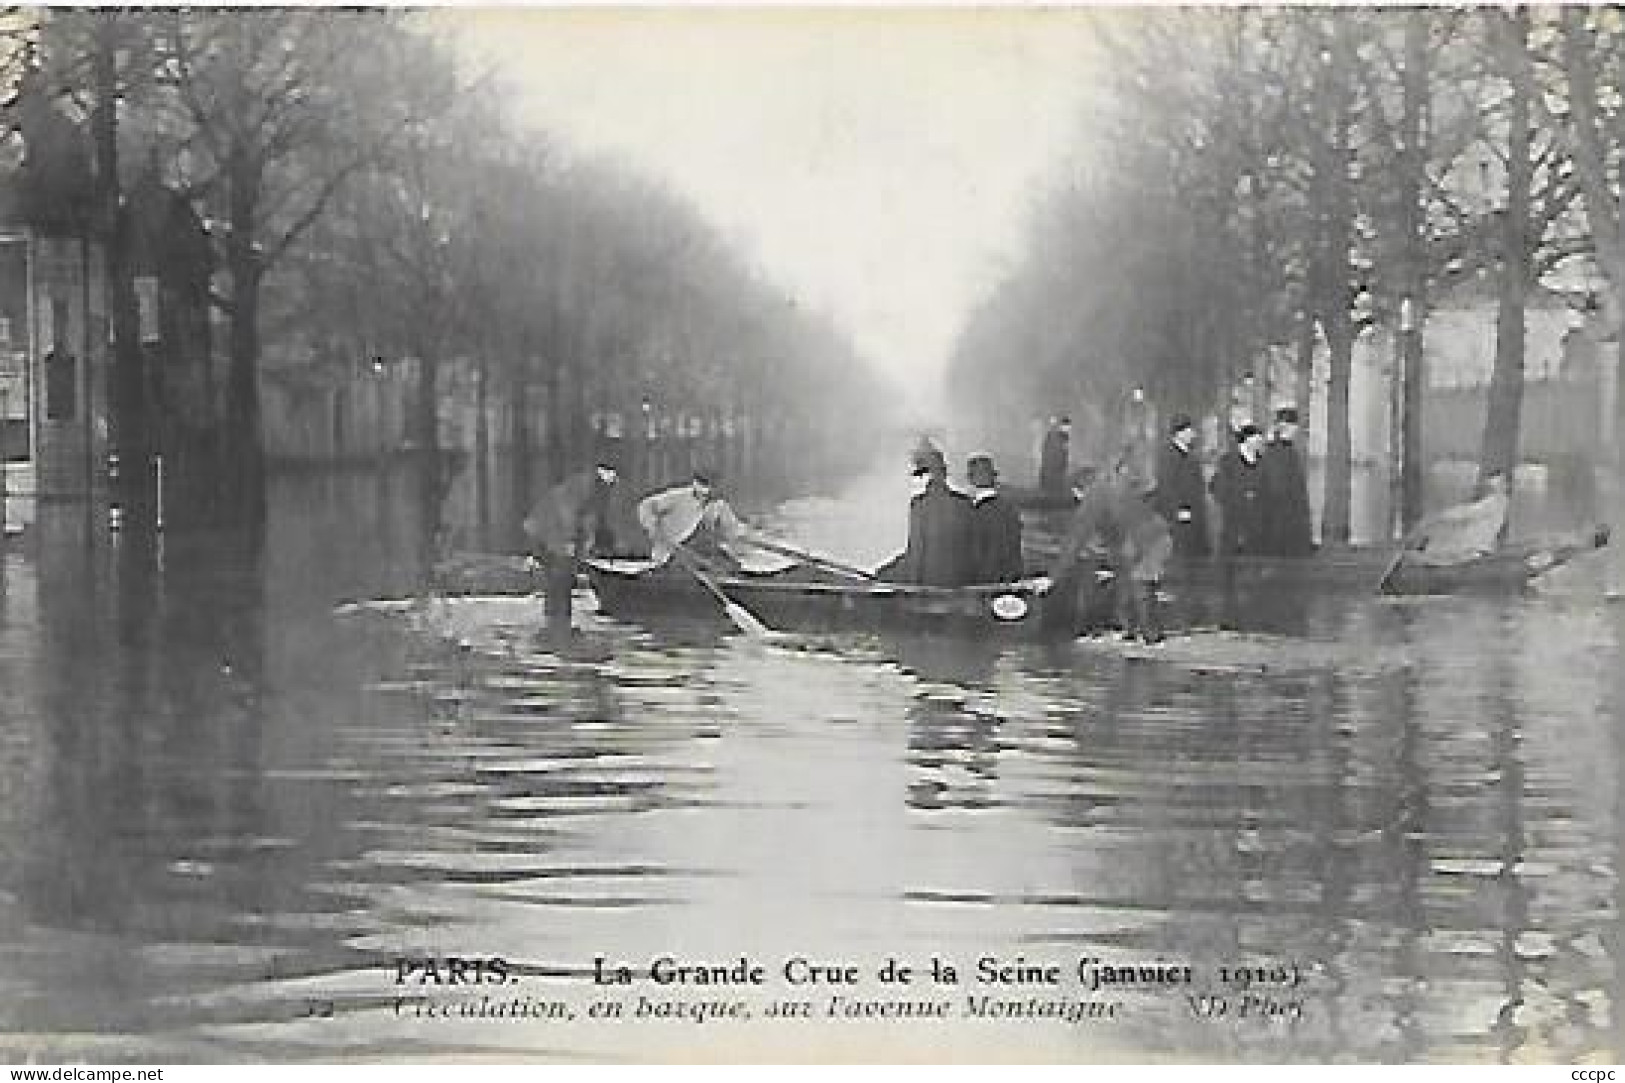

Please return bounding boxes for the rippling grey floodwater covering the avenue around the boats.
[0,465,1625,1062]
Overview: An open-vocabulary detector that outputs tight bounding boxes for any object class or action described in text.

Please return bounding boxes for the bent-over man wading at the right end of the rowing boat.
[1048,455,1173,642]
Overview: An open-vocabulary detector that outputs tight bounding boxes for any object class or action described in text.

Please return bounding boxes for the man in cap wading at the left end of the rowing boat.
[523,437,621,644]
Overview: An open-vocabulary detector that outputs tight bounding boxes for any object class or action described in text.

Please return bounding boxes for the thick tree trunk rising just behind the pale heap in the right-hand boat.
[1479,10,1532,483]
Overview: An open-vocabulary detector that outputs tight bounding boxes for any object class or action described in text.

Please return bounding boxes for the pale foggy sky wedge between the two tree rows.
[440,8,1090,410]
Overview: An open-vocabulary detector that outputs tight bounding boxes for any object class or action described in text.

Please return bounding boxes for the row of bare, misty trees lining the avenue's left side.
[5,8,882,536]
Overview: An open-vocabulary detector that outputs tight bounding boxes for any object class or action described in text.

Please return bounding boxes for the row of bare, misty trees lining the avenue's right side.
[952,7,1625,543]
